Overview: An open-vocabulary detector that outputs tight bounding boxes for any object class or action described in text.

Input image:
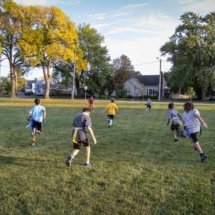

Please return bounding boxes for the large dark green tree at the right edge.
[161,12,215,100]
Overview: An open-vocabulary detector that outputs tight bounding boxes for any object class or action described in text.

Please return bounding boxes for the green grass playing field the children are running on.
[0,99,215,215]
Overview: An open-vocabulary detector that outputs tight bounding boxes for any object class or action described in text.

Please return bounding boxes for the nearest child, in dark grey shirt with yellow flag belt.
[66,108,97,167]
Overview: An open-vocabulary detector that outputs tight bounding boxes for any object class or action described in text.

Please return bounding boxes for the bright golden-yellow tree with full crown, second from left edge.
[20,6,78,99]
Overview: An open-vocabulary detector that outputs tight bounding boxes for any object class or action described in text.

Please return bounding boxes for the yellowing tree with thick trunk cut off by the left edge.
[0,0,25,98]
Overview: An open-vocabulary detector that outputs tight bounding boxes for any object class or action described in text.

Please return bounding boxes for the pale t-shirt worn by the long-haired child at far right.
[183,109,201,134]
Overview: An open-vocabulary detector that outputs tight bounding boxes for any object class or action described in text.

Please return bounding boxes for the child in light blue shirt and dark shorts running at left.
[28,98,46,146]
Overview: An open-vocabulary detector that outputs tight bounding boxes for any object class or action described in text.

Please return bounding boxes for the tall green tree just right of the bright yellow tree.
[78,24,113,96]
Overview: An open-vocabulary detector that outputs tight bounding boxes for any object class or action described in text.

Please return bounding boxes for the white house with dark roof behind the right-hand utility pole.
[124,75,169,97]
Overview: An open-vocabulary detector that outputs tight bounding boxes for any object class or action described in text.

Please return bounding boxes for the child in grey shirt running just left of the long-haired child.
[167,103,182,142]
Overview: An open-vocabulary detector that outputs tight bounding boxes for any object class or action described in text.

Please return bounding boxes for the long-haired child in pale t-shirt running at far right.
[183,102,208,162]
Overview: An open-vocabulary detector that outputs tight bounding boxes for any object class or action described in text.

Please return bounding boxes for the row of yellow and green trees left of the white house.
[0,0,138,98]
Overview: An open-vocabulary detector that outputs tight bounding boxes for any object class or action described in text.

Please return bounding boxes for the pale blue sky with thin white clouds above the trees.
[0,0,215,78]
